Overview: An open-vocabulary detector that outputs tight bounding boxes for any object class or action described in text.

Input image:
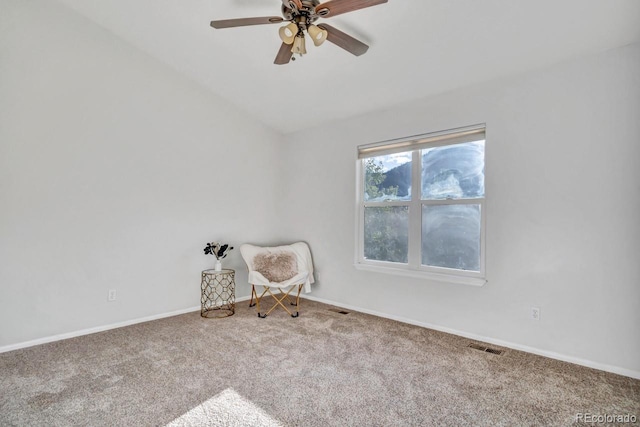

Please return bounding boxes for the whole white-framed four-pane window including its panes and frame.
[356,125,485,285]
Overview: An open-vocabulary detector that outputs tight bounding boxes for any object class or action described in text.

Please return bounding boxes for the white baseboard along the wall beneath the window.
[300,295,640,379]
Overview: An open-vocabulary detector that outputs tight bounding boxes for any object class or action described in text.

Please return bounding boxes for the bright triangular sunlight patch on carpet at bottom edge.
[167,388,283,427]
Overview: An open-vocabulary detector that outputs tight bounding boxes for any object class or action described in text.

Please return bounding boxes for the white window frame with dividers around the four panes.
[354,124,487,286]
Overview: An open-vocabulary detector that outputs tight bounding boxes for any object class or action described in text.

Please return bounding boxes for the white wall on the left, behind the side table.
[0,0,281,347]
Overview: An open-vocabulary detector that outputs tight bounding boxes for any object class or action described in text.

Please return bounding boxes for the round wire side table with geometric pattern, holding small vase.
[200,269,236,317]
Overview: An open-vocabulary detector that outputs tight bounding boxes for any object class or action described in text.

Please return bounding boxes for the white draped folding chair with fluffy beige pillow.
[240,242,314,318]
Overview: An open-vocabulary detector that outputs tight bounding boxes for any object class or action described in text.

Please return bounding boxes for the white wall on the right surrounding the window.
[283,45,640,376]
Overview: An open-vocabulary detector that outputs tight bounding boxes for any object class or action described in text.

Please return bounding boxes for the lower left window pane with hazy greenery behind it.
[364,206,409,263]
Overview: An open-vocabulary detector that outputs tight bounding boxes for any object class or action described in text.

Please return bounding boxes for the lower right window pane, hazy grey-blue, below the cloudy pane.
[422,205,480,271]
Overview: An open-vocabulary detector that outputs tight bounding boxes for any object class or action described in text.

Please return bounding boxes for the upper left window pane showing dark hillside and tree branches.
[362,152,411,202]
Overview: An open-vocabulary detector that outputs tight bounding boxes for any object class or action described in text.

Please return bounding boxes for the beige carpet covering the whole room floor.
[0,300,640,426]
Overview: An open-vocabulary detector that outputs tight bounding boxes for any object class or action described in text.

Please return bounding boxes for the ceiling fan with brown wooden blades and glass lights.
[211,0,388,65]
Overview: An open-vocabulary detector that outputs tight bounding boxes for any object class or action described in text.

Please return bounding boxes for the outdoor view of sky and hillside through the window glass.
[362,140,484,271]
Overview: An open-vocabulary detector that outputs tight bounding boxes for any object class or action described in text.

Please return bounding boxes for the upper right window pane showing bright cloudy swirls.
[421,141,484,200]
